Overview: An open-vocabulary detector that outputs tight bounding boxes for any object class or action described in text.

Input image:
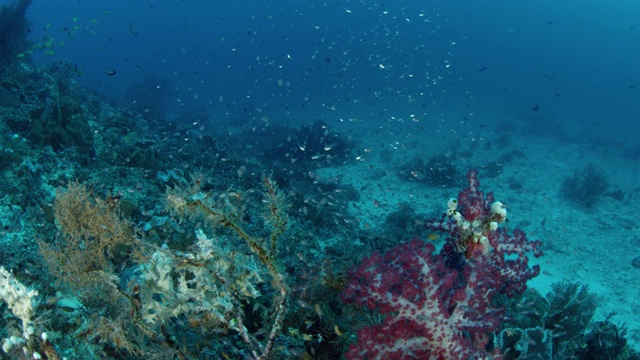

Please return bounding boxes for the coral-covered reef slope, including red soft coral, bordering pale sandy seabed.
[0,31,635,359]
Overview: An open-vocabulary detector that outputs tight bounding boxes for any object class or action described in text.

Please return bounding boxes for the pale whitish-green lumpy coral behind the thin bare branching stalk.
[139,230,262,326]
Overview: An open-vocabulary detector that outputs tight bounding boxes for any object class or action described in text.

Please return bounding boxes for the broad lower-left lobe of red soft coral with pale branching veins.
[342,240,490,359]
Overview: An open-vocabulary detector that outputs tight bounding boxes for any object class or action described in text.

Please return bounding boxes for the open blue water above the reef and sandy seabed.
[23,1,640,143]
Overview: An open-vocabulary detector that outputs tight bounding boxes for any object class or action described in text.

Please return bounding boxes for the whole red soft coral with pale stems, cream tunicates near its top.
[342,171,540,359]
